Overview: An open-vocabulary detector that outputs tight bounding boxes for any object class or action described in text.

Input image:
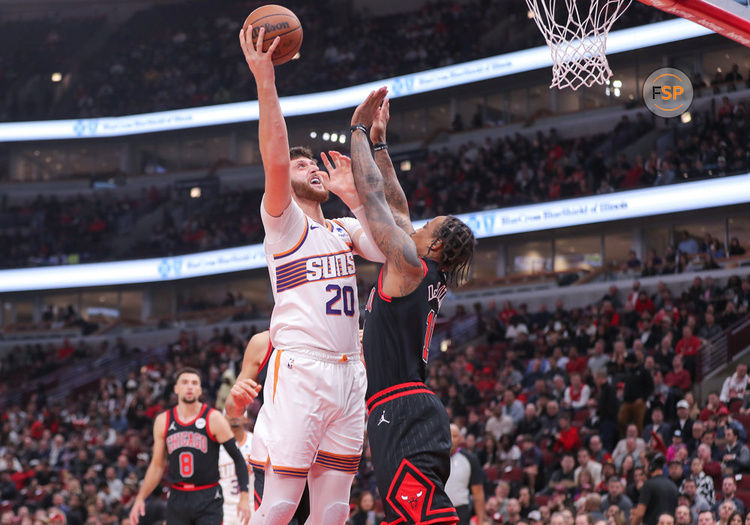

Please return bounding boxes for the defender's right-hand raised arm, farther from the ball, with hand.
[370,98,414,235]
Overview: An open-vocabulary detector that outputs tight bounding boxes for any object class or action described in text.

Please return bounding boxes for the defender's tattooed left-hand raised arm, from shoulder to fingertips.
[351,92,424,295]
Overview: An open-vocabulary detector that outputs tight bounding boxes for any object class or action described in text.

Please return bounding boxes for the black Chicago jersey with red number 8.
[166,405,220,487]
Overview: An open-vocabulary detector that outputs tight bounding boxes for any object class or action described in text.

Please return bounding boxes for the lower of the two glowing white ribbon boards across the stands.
[0,173,750,293]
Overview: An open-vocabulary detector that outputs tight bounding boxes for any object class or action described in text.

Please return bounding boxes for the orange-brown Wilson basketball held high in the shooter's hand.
[247,4,302,66]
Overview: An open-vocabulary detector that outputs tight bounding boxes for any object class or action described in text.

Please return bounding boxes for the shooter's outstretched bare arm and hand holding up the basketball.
[240,26,292,217]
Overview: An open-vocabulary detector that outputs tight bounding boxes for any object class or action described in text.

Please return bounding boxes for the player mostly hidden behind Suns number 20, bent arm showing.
[224,330,310,525]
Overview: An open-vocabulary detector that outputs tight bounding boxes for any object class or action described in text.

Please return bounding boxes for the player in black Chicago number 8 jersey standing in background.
[130,368,250,525]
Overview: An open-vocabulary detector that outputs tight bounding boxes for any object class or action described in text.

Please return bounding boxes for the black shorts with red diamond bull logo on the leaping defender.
[367,385,458,525]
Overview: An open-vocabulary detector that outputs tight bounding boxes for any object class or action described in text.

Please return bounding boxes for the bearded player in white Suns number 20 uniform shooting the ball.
[239,27,384,525]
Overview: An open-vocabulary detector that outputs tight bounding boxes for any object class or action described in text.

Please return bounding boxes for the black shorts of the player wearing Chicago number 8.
[167,483,224,525]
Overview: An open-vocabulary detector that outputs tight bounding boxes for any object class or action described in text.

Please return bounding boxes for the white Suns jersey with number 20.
[261,199,362,354]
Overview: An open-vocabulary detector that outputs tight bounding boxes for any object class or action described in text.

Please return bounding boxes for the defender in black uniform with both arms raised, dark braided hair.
[351,88,475,525]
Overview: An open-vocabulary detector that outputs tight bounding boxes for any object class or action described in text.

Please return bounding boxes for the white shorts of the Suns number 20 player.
[250,349,367,477]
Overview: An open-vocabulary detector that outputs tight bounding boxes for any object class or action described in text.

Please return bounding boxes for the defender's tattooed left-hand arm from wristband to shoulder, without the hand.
[351,131,423,294]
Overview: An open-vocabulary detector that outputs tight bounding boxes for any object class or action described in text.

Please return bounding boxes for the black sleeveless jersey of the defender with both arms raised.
[362,259,447,399]
